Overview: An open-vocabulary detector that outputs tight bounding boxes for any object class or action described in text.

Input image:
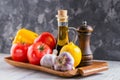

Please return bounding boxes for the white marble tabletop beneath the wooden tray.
[0,54,120,80]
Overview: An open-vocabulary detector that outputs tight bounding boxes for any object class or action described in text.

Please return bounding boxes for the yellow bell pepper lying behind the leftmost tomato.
[12,28,38,44]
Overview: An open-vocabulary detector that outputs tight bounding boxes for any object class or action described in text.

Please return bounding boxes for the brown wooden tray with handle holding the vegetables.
[5,57,108,77]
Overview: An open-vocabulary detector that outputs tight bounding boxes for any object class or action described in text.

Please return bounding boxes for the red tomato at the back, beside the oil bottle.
[34,32,56,49]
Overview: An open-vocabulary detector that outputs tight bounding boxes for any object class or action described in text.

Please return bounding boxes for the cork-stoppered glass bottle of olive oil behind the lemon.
[56,10,69,52]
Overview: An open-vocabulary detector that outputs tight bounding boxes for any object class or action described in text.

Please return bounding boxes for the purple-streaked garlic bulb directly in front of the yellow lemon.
[54,52,74,71]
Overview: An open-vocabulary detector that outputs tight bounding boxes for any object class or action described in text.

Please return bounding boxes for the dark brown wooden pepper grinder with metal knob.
[77,21,93,66]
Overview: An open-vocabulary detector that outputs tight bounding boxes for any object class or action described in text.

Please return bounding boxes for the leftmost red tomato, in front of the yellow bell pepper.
[10,43,30,62]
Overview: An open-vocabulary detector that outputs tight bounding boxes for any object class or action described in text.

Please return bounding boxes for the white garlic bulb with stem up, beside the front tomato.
[40,49,58,68]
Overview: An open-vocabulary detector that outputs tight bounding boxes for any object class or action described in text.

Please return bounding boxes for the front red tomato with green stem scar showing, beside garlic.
[27,42,52,65]
